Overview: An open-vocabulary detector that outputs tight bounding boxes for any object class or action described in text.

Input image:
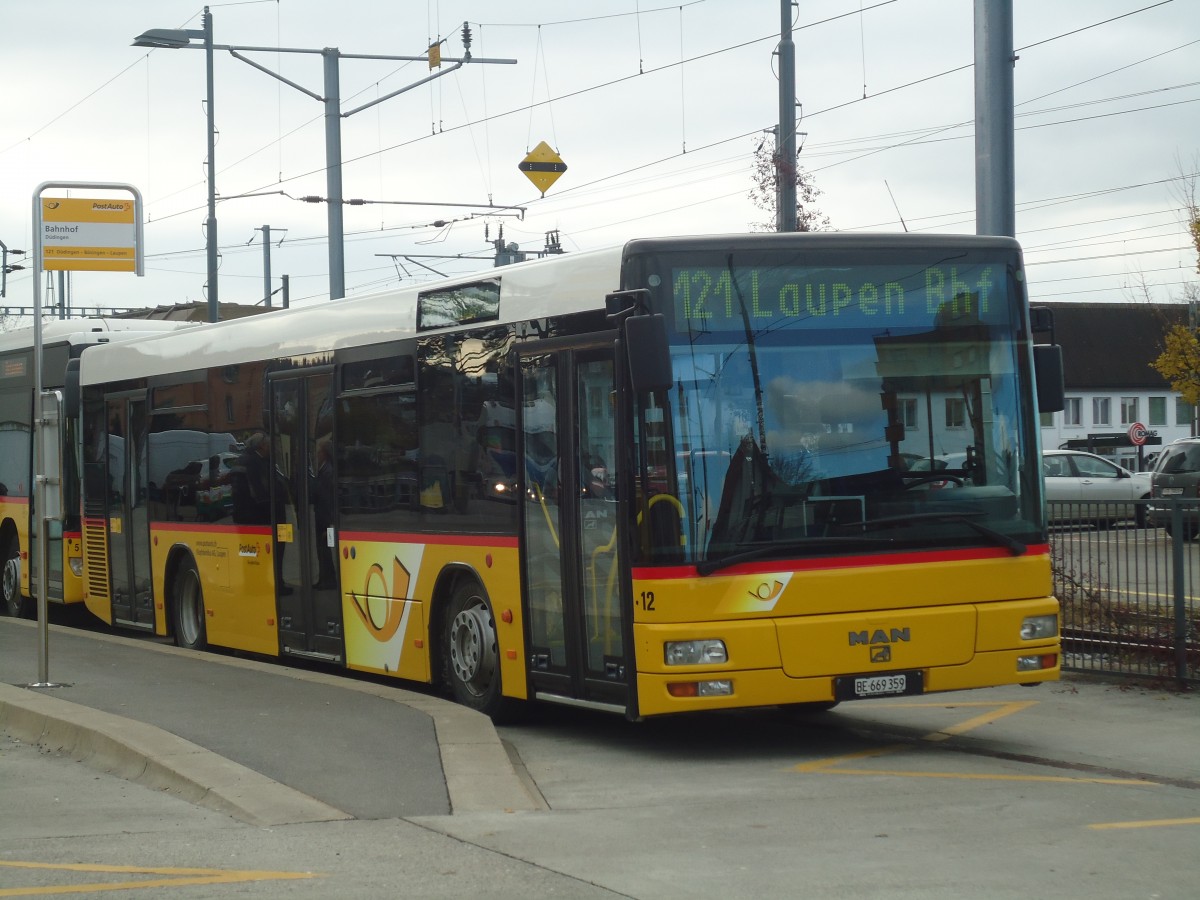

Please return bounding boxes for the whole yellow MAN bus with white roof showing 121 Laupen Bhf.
[80,234,1062,719]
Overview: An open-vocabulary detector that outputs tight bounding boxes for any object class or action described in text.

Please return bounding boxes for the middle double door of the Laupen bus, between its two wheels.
[271,370,344,662]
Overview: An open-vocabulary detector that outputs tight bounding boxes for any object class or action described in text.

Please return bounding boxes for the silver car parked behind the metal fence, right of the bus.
[1042,450,1151,527]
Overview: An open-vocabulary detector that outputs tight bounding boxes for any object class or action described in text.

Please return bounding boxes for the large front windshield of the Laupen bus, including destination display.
[635,248,1044,572]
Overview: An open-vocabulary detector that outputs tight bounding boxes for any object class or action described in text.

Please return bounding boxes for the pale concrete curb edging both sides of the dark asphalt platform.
[0,622,544,824]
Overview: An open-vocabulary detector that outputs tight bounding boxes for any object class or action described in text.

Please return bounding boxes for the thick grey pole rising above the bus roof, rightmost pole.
[974,0,1016,238]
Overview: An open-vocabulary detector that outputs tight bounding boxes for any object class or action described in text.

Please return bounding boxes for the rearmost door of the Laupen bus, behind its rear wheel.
[106,394,154,630]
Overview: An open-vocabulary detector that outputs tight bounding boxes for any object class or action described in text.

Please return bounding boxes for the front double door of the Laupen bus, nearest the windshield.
[521,341,634,710]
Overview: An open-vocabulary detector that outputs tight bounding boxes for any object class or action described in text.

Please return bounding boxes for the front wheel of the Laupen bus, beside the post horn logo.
[444,582,503,715]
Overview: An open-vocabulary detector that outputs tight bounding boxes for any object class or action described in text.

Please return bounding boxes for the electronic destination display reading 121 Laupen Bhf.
[671,263,1009,332]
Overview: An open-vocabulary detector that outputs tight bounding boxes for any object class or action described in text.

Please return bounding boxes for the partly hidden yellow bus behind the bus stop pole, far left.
[0,318,193,617]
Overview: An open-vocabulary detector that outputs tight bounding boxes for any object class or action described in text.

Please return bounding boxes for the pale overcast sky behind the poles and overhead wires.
[0,0,1200,321]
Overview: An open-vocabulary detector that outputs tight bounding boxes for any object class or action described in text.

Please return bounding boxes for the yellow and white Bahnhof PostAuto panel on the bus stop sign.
[41,197,137,272]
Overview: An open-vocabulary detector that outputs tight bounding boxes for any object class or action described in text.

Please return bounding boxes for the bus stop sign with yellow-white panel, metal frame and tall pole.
[29,181,144,688]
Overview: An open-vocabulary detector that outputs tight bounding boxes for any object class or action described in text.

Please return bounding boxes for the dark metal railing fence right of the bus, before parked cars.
[1049,500,1200,686]
